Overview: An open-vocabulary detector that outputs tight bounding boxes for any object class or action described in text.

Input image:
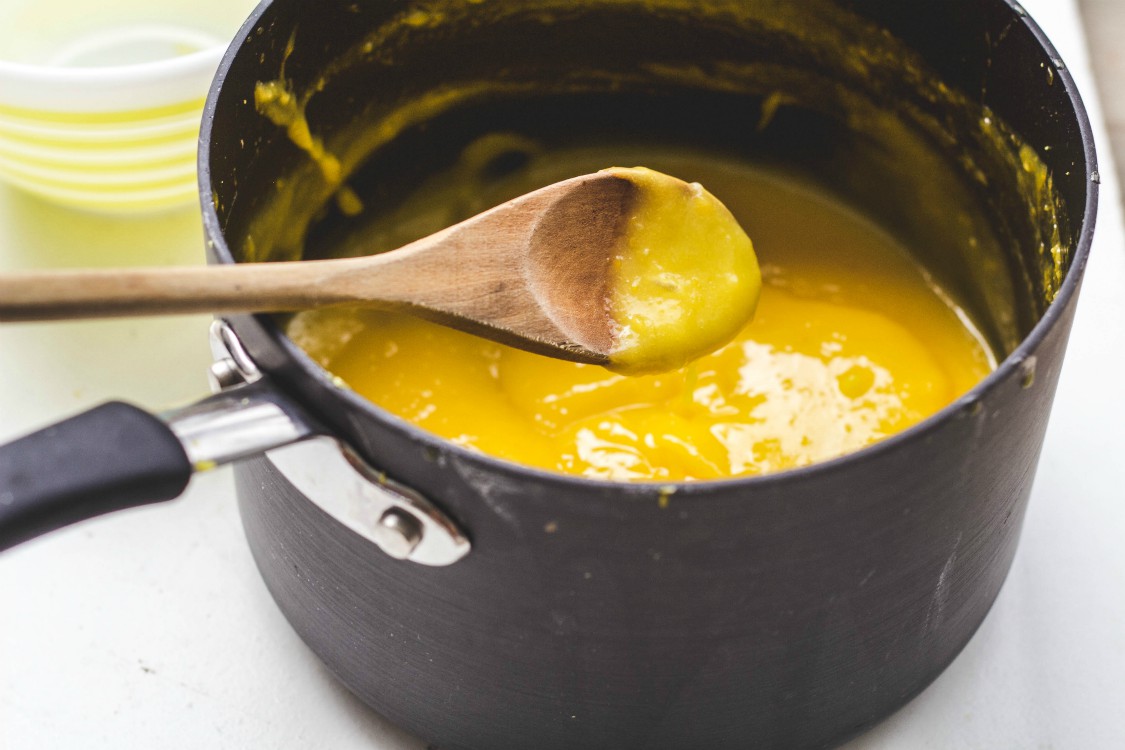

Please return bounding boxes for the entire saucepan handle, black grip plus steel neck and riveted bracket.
[0,320,471,566]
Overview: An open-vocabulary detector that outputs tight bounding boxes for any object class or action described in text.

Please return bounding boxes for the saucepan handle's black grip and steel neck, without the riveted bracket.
[0,381,317,550]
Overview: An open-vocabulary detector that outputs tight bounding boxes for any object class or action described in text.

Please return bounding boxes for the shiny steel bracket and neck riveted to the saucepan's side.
[173,320,471,566]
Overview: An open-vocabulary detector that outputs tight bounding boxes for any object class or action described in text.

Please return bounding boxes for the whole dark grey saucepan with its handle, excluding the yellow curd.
[0,0,1098,750]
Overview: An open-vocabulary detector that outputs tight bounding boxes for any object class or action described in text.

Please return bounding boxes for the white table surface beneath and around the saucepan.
[0,0,1125,750]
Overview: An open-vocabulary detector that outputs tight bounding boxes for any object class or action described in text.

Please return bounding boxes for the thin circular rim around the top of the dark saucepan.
[198,0,1100,499]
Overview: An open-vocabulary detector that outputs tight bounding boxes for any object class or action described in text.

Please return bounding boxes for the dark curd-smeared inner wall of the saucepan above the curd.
[205,0,1087,358]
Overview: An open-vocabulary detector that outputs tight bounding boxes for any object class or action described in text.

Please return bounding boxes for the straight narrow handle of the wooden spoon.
[0,261,393,322]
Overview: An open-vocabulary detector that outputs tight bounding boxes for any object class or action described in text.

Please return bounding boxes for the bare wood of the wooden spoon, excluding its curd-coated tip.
[0,169,756,373]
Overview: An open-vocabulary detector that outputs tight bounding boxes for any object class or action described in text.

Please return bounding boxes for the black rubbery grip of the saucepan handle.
[0,401,191,550]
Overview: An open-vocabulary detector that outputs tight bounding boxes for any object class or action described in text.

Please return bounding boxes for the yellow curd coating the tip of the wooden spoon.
[605,168,762,374]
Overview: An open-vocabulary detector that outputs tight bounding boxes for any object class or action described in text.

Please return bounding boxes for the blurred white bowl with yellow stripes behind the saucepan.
[0,0,255,214]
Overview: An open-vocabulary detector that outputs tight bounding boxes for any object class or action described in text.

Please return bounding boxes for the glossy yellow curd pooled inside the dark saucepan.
[288,148,996,481]
